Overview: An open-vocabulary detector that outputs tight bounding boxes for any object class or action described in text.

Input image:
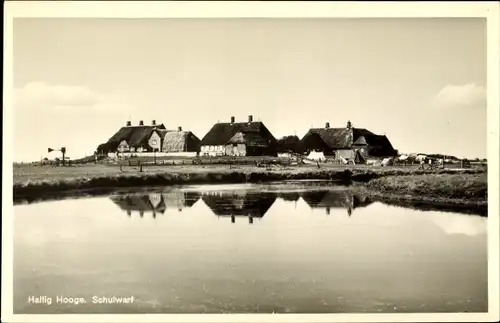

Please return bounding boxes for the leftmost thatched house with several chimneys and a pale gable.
[97,120,165,154]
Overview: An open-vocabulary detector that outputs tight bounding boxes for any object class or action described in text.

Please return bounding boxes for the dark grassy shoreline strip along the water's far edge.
[13,167,488,214]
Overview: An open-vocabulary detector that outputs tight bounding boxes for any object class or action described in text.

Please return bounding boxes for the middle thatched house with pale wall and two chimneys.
[200,116,277,156]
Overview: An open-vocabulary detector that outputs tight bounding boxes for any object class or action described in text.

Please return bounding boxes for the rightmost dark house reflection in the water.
[301,190,372,216]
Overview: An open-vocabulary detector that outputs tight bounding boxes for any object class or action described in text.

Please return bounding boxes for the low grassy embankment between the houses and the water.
[13,164,487,207]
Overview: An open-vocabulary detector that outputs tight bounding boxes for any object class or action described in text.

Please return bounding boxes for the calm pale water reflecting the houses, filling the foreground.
[14,184,488,313]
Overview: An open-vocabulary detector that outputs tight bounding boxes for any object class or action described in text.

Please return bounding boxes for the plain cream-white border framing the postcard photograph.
[2,1,500,322]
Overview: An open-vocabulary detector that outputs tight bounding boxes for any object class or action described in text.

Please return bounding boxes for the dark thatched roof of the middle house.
[201,121,276,146]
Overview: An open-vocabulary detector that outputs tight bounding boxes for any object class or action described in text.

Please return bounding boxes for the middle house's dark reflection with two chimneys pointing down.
[201,192,276,223]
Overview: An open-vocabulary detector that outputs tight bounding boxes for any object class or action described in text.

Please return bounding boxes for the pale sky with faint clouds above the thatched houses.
[13,18,487,161]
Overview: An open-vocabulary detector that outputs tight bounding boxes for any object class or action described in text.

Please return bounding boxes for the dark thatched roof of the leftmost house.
[100,124,165,152]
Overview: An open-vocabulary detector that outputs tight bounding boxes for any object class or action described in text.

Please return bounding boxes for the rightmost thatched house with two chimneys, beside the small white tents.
[299,121,397,162]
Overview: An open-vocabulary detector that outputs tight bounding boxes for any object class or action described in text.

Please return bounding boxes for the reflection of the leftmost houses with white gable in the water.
[111,192,199,217]
